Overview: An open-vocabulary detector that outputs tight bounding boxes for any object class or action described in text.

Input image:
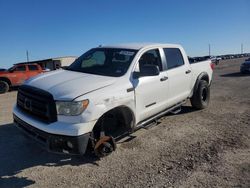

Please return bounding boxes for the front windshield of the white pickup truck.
[67,48,137,77]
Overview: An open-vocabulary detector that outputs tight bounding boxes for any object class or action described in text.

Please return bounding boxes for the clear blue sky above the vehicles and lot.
[0,0,250,68]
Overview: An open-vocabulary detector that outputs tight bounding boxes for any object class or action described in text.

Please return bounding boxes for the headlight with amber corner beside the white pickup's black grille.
[56,100,89,116]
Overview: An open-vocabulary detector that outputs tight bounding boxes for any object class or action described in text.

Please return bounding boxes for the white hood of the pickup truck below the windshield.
[24,70,115,101]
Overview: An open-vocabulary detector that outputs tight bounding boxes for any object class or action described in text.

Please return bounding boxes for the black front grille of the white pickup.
[17,85,57,123]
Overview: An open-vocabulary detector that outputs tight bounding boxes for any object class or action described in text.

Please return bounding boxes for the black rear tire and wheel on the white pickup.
[190,80,210,110]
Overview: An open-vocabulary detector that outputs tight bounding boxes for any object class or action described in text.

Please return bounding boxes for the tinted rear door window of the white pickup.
[163,48,184,69]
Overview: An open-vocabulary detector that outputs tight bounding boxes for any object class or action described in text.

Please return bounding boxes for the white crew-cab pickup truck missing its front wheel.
[13,44,213,157]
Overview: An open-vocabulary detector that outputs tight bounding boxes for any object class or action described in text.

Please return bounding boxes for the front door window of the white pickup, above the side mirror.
[139,49,163,71]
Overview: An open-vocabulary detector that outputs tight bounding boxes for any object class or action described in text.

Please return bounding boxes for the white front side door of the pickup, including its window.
[134,49,168,123]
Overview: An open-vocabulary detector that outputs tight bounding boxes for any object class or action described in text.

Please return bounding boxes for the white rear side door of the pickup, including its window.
[163,48,191,105]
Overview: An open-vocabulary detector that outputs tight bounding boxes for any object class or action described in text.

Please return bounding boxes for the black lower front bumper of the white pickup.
[13,115,90,155]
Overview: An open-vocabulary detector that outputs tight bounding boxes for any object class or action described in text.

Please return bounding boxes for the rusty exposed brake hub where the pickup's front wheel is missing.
[94,136,116,157]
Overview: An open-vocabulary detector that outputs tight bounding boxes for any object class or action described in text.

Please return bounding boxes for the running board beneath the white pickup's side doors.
[135,100,186,131]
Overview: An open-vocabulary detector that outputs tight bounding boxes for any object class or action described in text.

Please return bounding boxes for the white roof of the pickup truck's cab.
[100,43,179,50]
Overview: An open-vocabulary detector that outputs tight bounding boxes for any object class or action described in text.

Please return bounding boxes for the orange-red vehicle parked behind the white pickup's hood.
[0,63,44,94]
